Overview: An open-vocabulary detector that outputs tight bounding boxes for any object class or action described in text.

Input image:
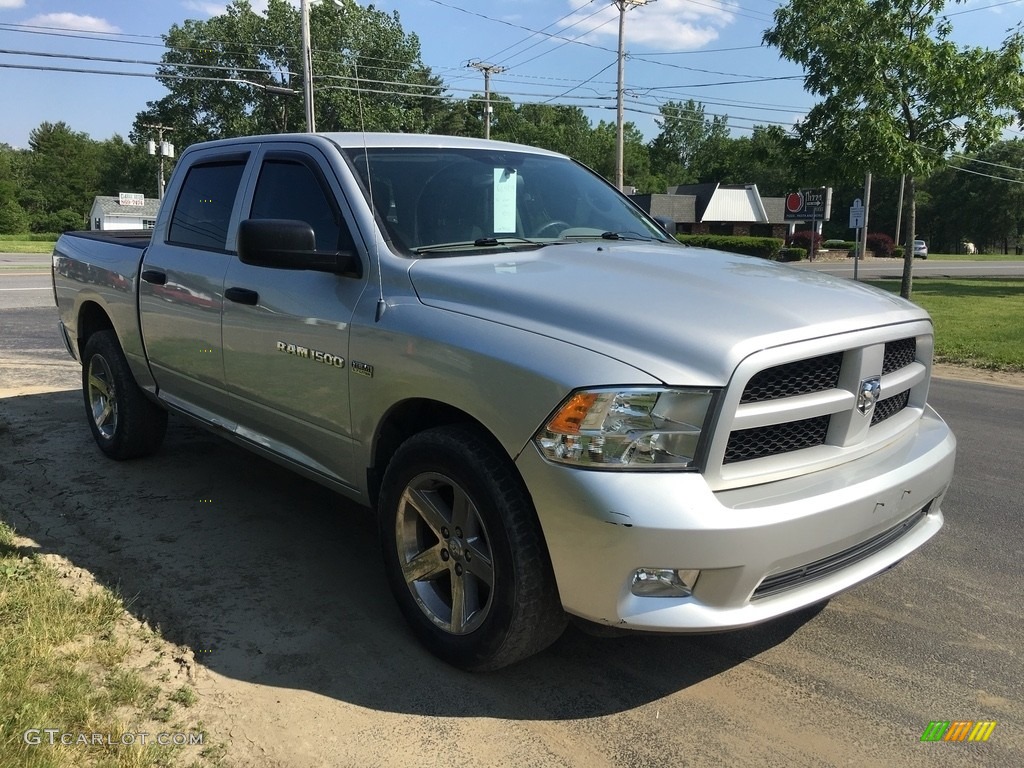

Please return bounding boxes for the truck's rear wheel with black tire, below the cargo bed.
[82,331,167,460]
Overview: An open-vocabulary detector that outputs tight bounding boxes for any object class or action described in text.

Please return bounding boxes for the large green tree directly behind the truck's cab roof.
[132,0,452,146]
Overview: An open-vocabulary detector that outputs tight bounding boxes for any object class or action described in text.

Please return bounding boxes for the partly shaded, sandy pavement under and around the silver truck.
[0,278,1024,768]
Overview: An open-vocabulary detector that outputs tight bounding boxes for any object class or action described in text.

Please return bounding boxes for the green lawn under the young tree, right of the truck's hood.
[873,278,1024,371]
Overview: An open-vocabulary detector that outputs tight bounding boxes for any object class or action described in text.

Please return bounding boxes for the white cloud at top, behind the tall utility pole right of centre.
[562,0,735,50]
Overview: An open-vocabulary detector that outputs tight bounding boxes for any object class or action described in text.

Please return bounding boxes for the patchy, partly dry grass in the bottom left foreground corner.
[0,520,220,768]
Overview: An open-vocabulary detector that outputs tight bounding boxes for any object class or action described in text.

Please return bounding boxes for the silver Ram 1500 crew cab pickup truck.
[53,134,955,670]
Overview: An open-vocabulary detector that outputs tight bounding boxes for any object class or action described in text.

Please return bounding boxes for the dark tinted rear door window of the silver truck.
[167,158,246,251]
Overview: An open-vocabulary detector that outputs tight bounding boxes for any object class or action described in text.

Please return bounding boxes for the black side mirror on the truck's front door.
[238,219,362,278]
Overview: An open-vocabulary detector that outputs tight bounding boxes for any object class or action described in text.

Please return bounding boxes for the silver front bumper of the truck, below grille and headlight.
[517,407,956,632]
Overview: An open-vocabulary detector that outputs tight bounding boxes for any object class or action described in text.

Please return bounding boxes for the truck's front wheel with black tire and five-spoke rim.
[378,425,565,672]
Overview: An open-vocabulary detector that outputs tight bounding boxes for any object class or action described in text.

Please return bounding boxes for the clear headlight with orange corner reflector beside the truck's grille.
[534,388,715,469]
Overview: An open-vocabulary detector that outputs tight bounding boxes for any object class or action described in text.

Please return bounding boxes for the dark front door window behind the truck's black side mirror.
[249,158,355,251]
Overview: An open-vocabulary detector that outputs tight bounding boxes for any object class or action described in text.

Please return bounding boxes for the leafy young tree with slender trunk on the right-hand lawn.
[764,0,1024,298]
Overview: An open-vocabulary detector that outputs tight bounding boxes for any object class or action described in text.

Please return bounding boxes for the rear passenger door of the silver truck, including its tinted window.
[139,145,255,419]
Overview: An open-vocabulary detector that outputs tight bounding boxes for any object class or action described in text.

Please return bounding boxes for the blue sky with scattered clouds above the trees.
[0,0,1024,147]
